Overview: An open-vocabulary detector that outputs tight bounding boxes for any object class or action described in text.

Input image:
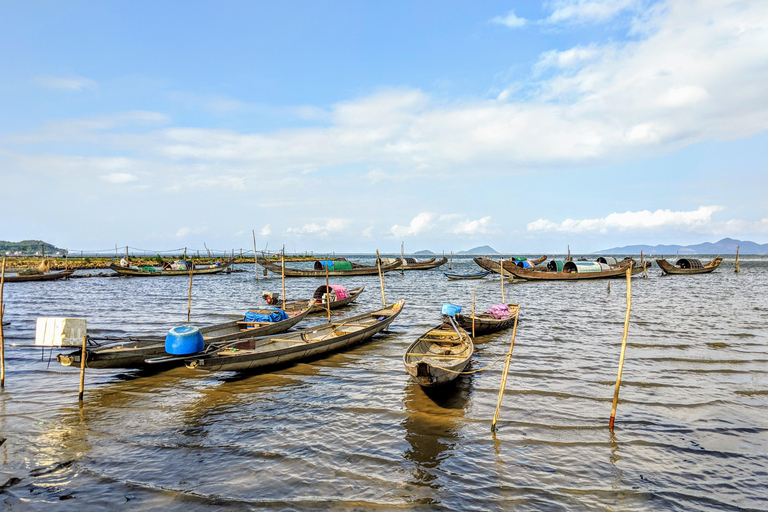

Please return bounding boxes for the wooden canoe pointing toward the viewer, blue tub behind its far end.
[403,317,475,387]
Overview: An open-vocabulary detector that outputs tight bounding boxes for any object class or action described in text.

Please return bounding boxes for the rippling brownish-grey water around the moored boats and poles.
[0,257,768,512]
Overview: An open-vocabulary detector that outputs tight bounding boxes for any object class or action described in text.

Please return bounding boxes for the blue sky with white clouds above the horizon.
[0,0,768,254]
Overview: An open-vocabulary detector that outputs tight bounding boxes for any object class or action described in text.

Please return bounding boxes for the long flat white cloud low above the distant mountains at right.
[527,206,725,234]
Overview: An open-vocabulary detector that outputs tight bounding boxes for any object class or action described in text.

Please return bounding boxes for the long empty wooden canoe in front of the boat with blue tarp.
[186,300,405,371]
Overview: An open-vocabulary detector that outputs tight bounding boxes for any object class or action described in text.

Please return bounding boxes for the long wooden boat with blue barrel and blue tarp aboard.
[56,302,314,368]
